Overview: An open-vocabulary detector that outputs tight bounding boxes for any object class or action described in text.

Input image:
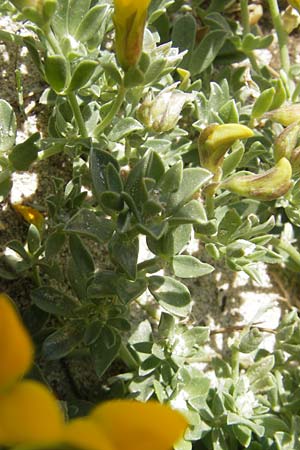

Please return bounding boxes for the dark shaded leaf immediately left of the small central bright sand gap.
[109,233,139,280]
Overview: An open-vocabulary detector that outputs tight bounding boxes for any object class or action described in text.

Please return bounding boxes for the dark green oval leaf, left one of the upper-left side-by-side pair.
[44,55,68,92]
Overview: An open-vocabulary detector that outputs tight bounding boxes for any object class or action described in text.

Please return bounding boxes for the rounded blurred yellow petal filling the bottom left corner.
[0,380,64,446]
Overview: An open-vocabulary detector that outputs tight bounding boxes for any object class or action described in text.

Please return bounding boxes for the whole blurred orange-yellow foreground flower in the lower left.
[0,294,187,450]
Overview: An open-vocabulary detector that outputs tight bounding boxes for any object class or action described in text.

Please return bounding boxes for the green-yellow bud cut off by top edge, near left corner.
[11,0,57,27]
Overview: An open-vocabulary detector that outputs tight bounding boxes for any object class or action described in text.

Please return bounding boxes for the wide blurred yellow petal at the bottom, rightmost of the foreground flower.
[91,400,187,450]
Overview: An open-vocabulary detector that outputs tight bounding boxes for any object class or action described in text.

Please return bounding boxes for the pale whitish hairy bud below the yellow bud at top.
[138,84,194,133]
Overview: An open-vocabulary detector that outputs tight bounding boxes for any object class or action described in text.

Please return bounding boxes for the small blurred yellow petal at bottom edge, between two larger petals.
[63,419,115,450]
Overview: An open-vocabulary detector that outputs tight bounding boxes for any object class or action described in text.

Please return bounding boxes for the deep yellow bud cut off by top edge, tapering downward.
[113,0,150,70]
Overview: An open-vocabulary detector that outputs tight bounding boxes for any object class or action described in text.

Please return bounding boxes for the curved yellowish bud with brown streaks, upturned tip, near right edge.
[220,158,292,201]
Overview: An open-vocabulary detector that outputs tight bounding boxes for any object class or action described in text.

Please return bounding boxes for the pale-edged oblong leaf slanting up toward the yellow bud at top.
[75,4,109,42]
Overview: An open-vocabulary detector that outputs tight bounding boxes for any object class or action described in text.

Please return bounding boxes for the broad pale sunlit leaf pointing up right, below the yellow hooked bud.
[167,167,212,213]
